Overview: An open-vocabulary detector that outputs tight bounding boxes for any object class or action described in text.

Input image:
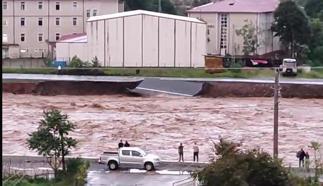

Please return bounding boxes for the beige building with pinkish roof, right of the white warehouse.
[188,0,280,55]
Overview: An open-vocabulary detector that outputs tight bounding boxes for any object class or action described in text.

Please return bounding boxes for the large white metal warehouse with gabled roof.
[57,10,206,67]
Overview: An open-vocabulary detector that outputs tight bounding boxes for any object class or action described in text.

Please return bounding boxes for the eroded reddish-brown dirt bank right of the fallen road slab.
[199,82,323,98]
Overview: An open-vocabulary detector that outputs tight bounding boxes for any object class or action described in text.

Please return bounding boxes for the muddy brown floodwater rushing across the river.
[2,93,323,166]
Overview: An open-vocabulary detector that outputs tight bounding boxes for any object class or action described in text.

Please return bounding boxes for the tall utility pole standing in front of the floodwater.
[274,68,280,158]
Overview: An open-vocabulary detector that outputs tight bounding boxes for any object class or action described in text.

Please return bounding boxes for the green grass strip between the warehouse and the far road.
[2,68,323,78]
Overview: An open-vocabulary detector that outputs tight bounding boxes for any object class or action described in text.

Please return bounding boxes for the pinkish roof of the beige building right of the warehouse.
[187,0,279,13]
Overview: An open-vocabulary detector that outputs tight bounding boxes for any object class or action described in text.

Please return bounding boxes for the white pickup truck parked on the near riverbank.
[99,147,160,171]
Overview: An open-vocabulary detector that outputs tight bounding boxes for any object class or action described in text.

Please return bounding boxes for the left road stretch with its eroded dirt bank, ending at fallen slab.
[2,74,143,95]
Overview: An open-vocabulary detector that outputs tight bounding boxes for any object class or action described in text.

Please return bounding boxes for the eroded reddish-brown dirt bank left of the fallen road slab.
[2,81,140,95]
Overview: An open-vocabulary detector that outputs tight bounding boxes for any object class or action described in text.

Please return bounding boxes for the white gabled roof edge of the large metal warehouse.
[87,10,204,23]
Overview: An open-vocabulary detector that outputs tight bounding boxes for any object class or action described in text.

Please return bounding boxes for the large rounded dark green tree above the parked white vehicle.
[272,0,311,57]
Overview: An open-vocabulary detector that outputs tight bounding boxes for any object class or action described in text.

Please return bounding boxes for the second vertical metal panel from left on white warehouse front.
[107,18,124,67]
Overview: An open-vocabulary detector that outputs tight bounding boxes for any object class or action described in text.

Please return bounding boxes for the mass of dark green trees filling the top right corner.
[272,0,323,66]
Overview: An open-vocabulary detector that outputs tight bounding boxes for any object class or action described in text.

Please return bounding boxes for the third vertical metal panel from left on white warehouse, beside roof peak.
[124,15,142,67]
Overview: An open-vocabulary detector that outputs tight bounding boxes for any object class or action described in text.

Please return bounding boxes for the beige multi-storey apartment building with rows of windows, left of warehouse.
[2,0,123,58]
